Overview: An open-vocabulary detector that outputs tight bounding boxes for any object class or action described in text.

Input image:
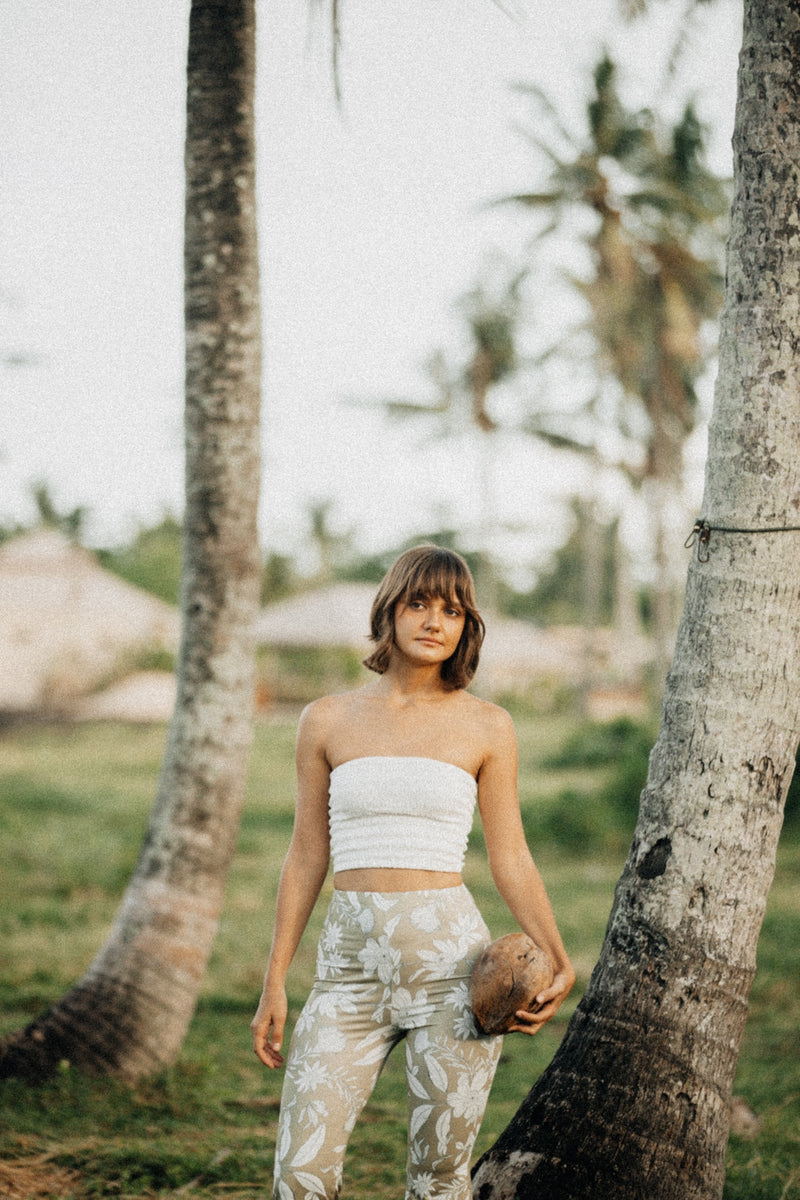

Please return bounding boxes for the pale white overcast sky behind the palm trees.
[0,0,740,576]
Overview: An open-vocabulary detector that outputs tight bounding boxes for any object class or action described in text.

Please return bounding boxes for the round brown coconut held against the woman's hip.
[469,934,555,1033]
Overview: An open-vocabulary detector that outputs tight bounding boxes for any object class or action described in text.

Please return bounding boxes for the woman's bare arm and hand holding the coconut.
[477,707,575,1033]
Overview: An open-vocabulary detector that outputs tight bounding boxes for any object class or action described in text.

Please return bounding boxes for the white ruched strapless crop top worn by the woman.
[329,755,477,871]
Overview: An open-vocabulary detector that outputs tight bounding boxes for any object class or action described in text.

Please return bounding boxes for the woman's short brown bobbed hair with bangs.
[363,546,485,690]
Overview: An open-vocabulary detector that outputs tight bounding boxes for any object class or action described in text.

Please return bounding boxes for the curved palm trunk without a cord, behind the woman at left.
[0,0,260,1080]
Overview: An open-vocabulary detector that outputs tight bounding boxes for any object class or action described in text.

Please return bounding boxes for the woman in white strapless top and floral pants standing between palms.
[252,546,575,1200]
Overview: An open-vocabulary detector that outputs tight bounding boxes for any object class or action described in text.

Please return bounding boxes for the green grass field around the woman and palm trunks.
[0,716,800,1200]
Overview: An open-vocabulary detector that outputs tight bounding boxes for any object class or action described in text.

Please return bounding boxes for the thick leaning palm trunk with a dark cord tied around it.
[474,0,800,1200]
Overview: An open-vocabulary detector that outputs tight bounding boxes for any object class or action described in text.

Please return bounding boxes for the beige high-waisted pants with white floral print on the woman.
[273,886,503,1200]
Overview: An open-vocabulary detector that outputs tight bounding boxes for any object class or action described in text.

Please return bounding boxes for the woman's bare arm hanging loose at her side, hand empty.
[251,701,330,1067]
